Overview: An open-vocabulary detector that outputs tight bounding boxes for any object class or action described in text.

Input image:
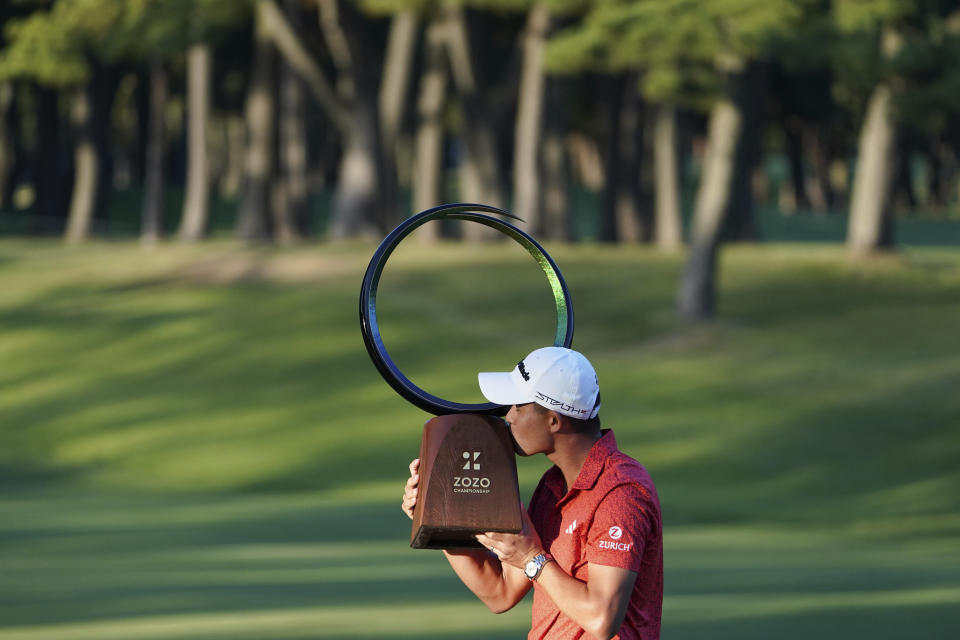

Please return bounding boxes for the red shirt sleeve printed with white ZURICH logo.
[585,484,652,572]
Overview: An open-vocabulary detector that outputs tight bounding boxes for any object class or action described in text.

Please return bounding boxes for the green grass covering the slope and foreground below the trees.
[0,240,960,640]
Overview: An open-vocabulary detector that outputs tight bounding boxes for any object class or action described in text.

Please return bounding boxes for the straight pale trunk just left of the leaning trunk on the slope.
[653,104,683,250]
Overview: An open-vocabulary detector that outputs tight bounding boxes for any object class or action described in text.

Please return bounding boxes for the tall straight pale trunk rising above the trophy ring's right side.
[513,2,550,233]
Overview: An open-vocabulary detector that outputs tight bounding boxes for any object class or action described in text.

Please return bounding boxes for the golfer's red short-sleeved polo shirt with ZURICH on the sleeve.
[528,430,663,640]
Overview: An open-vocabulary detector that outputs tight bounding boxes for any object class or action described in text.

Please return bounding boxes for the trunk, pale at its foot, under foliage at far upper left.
[66,82,100,244]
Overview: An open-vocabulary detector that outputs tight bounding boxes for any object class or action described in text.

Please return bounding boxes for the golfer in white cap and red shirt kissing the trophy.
[402,347,663,640]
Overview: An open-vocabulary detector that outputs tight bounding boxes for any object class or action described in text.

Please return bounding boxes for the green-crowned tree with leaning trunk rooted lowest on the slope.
[550,0,801,320]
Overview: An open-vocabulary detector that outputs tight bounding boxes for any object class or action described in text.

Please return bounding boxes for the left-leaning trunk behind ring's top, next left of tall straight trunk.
[443,5,503,242]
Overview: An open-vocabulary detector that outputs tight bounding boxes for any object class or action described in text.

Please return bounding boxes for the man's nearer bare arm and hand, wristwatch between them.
[477,511,637,640]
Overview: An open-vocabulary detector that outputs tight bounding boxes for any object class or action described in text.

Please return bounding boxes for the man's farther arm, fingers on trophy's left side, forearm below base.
[401,460,530,613]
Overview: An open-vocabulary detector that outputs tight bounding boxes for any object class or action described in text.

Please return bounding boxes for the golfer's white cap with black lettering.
[477,347,600,420]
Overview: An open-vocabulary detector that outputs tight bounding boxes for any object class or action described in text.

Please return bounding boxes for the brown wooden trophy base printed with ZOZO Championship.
[410,413,523,549]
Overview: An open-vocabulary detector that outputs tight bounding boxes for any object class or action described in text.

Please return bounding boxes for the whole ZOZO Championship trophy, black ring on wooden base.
[360,204,573,549]
